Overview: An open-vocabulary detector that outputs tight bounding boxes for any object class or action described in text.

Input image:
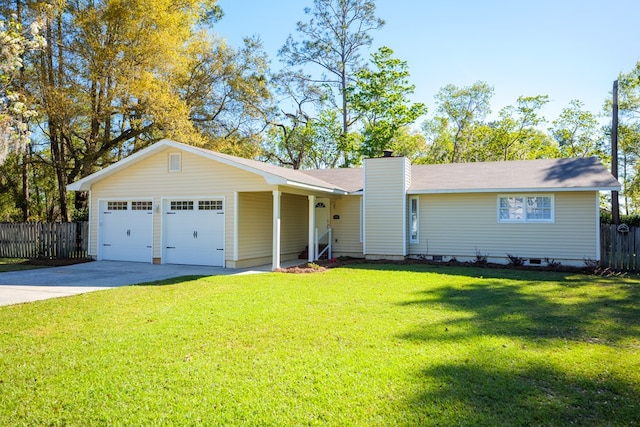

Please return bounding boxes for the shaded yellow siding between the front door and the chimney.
[331,196,362,257]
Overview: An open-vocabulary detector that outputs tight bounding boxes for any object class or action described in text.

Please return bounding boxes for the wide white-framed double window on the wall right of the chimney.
[498,195,554,222]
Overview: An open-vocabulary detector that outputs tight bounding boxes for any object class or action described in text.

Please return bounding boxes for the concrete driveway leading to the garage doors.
[0,261,282,306]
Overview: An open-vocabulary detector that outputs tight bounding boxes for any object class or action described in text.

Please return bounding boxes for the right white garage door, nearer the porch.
[164,199,224,267]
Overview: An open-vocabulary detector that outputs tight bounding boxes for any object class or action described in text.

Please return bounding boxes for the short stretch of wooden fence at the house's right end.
[600,224,640,271]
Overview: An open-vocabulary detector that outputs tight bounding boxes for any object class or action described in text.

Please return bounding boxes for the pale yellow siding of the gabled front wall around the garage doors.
[90,149,273,260]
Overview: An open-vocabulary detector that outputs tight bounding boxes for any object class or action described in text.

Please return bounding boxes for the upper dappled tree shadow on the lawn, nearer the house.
[401,280,640,345]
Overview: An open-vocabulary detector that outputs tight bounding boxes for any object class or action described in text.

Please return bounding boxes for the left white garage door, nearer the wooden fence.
[98,200,153,262]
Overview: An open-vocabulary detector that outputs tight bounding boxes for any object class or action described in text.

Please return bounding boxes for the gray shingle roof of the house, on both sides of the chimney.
[67,140,620,194]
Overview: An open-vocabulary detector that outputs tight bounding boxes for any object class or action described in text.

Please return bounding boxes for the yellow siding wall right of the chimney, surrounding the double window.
[410,192,596,264]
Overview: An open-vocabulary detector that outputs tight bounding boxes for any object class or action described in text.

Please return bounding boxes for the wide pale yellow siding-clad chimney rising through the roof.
[364,157,408,257]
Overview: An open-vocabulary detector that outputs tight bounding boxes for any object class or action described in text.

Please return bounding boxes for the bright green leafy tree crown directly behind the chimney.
[347,46,427,157]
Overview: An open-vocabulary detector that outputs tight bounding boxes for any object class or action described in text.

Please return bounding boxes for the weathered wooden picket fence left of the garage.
[0,221,89,258]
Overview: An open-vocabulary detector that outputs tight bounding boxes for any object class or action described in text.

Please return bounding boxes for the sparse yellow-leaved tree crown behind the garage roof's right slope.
[188,34,274,158]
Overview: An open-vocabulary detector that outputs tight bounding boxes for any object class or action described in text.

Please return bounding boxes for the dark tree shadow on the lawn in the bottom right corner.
[408,364,640,426]
